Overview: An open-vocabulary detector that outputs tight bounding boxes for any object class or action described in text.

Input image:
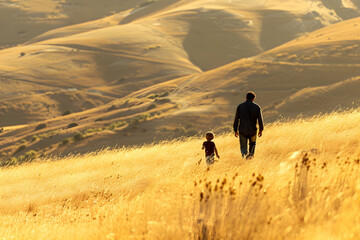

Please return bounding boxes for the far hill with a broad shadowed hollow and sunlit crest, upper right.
[119,0,359,70]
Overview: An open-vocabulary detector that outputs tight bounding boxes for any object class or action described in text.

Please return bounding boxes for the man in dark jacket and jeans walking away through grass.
[234,91,264,159]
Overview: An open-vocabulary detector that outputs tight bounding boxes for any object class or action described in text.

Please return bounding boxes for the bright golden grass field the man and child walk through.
[0,109,360,239]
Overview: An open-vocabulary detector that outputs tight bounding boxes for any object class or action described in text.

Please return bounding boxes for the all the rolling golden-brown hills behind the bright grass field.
[0,0,360,162]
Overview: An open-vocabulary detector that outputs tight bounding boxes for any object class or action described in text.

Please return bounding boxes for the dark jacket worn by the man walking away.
[234,100,264,137]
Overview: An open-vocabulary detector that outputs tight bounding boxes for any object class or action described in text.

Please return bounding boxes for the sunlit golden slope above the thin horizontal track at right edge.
[262,18,360,64]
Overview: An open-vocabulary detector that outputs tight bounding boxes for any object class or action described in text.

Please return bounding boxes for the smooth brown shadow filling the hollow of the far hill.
[182,9,262,71]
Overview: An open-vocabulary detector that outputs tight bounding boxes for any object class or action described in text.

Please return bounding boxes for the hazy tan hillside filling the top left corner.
[0,0,148,47]
